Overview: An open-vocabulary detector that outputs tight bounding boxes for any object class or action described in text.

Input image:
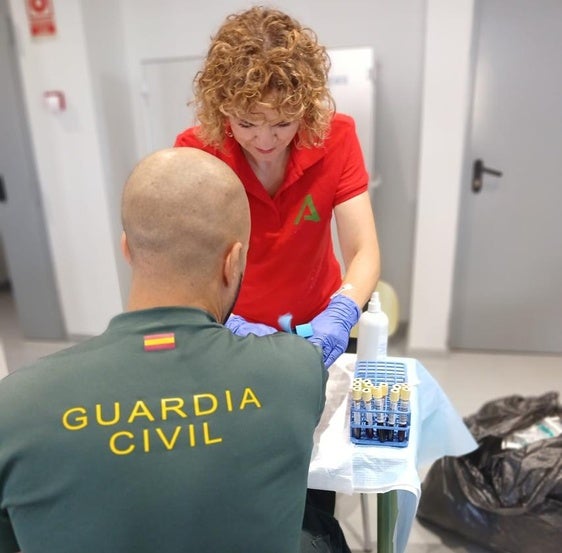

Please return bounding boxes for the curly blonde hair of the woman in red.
[194,6,335,148]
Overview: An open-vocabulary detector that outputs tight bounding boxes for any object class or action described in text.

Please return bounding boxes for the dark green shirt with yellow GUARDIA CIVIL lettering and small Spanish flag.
[0,308,327,553]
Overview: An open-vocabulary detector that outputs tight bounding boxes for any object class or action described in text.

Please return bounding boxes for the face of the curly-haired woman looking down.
[228,107,300,162]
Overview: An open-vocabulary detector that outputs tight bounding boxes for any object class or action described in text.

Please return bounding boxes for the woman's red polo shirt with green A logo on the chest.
[175,114,369,328]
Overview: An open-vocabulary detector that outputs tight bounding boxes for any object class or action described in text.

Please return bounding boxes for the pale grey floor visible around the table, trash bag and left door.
[0,289,562,553]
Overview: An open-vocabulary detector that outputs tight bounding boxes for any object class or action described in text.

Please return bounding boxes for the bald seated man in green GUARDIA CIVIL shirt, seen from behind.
[0,148,327,553]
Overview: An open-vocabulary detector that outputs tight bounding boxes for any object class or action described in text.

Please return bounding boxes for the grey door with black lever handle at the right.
[450,0,562,353]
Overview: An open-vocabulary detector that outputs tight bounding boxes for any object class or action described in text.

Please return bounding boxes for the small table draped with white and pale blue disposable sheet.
[308,354,477,553]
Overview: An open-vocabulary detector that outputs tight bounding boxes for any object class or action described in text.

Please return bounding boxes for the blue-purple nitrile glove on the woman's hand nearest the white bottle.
[308,294,361,368]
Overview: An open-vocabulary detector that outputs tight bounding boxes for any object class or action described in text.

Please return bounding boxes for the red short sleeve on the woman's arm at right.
[332,117,369,205]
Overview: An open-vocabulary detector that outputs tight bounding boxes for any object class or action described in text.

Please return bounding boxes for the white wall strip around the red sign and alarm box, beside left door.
[6,0,121,336]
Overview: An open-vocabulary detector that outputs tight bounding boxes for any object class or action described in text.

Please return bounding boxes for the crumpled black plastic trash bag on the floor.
[417,392,562,553]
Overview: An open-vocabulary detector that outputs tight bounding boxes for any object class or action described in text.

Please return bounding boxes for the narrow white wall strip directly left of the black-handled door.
[408,0,474,351]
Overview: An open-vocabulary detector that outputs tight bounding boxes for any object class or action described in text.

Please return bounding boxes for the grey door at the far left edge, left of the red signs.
[0,0,65,340]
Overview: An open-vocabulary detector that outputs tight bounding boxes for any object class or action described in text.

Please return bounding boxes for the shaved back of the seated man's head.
[121,148,250,302]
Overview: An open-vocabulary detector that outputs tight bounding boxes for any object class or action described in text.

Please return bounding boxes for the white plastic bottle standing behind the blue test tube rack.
[357,292,388,361]
